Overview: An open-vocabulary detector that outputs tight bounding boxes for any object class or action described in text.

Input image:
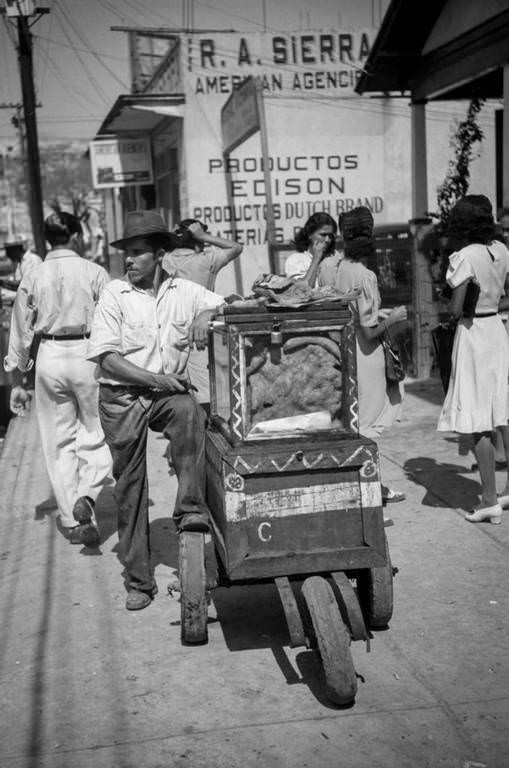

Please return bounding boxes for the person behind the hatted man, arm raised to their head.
[162,219,242,410]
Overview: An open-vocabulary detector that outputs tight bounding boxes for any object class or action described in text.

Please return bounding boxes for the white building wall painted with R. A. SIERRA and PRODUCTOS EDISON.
[176,29,385,290]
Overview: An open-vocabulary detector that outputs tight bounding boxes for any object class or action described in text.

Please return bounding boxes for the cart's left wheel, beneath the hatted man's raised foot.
[179,531,208,644]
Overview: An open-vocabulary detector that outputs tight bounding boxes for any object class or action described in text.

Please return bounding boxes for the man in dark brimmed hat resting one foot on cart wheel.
[88,211,223,610]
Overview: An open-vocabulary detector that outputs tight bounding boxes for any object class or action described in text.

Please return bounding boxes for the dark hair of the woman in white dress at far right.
[447,195,496,245]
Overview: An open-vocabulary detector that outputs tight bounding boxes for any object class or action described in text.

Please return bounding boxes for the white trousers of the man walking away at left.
[35,339,111,528]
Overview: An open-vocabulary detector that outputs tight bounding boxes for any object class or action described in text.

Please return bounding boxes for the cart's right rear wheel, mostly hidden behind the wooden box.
[357,536,393,629]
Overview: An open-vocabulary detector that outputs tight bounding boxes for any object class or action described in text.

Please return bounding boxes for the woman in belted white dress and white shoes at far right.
[437,195,509,524]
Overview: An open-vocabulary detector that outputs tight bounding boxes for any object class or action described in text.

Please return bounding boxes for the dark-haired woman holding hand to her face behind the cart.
[285,211,342,287]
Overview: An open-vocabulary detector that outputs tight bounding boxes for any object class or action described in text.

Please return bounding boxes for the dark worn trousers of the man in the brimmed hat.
[99,384,208,591]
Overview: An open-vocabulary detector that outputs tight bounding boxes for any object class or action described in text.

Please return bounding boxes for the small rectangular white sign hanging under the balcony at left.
[90,138,153,189]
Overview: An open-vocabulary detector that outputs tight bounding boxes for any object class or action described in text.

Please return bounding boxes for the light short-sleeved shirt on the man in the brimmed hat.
[87,277,223,384]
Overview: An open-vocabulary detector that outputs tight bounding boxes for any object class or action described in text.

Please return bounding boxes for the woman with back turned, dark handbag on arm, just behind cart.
[319,206,407,510]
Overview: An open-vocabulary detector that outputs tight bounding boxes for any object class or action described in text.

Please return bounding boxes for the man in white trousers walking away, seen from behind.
[4,212,111,546]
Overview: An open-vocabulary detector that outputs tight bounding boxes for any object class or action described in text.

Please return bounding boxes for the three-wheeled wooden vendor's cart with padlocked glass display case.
[180,303,393,704]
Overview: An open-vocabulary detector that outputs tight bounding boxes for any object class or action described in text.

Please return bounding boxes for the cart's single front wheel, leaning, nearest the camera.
[302,576,357,705]
